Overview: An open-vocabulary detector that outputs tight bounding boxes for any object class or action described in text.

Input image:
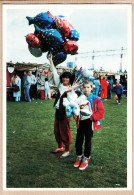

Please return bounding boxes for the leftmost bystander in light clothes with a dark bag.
[10,73,21,102]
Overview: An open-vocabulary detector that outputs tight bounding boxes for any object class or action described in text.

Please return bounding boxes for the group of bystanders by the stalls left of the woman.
[10,70,51,102]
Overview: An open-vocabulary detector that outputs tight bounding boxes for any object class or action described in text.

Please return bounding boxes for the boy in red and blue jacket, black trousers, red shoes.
[74,80,105,170]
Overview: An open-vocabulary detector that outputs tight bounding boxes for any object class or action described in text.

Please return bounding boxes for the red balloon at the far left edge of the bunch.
[26,33,41,48]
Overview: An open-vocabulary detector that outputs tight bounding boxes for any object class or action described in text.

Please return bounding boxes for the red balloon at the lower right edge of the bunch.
[63,40,78,55]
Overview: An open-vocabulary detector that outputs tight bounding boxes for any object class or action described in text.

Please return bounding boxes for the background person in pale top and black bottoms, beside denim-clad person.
[28,70,37,100]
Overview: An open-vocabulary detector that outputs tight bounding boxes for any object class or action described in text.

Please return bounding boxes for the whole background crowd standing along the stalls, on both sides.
[10,70,127,103]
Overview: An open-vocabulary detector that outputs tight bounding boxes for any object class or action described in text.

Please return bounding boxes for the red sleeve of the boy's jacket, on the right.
[90,100,105,121]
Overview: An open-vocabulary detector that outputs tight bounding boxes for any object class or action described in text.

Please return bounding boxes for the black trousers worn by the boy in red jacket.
[75,119,93,158]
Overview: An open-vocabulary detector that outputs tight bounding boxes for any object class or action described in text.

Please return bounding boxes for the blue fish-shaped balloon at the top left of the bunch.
[26,12,54,29]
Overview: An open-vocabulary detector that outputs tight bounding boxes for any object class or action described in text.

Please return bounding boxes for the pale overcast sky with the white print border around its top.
[3,4,131,72]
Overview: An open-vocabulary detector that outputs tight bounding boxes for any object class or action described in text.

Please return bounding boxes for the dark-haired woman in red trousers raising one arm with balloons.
[47,53,75,159]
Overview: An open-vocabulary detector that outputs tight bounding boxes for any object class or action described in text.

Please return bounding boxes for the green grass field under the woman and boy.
[7,95,127,188]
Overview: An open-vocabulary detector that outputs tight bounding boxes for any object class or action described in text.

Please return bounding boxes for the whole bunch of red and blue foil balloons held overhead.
[26,11,79,66]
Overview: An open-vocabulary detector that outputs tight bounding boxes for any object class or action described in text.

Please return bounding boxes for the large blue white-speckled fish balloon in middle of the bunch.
[35,25,63,48]
